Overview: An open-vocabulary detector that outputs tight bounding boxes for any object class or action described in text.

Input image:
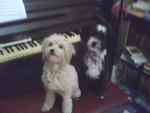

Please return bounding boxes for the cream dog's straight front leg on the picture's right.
[62,96,72,113]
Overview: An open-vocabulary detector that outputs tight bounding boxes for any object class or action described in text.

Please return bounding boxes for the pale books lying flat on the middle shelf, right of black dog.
[121,46,148,67]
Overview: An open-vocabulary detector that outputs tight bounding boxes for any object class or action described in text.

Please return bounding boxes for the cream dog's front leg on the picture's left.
[41,89,55,112]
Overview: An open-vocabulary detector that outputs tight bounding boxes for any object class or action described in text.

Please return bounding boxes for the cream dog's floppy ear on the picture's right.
[66,43,76,63]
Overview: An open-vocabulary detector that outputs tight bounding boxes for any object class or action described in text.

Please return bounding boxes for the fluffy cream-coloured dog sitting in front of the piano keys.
[41,34,81,113]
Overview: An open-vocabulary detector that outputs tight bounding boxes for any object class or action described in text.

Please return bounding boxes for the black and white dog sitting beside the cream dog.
[82,25,107,100]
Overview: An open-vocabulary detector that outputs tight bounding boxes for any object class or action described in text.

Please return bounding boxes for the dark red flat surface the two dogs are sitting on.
[0,82,129,113]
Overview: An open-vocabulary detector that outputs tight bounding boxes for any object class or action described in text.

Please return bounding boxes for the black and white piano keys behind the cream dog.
[0,32,81,63]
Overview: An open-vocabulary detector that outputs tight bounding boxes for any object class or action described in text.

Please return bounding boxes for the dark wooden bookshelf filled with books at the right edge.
[117,9,150,112]
